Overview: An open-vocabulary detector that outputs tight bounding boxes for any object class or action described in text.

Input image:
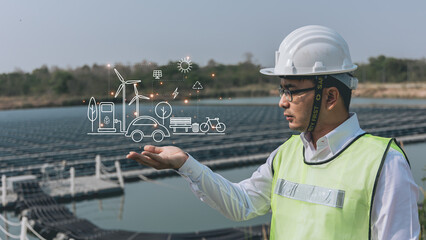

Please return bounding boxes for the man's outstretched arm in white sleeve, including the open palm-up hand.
[127,146,276,221]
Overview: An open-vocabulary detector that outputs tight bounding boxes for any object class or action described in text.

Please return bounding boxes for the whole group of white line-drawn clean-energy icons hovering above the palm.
[83,57,226,143]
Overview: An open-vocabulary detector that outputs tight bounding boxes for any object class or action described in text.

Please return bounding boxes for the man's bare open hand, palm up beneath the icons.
[126,145,188,170]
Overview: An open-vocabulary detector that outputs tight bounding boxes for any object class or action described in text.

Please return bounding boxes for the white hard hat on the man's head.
[260,25,358,89]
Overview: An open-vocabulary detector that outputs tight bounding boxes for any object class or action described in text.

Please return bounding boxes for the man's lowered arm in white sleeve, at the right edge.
[371,149,420,240]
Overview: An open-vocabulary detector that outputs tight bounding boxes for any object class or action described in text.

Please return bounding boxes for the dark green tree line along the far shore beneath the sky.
[0,55,426,98]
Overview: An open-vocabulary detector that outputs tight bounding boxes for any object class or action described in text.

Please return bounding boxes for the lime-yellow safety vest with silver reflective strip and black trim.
[270,134,407,240]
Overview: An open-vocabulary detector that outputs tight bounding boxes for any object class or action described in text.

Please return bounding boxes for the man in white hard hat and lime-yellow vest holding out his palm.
[127,26,420,240]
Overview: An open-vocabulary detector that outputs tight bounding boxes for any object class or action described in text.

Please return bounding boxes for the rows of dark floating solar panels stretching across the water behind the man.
[0,105,426,178]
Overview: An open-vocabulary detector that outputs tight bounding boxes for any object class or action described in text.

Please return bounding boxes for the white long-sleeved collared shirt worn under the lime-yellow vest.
[179,113,420,240]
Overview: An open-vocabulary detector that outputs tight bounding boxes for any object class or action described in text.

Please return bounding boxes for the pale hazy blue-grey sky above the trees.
[0,0,426,73]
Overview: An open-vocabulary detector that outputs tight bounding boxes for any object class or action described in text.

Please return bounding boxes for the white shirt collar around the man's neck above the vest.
[300,113,364,156]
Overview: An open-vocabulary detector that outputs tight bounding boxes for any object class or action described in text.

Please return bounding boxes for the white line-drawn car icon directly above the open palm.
[125,116,170,142]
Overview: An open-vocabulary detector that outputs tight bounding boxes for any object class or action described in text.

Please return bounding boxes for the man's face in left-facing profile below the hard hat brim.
[279,78,315,132]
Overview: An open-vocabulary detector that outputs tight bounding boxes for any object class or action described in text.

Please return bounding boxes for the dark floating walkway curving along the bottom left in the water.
[15,181,269,240]
